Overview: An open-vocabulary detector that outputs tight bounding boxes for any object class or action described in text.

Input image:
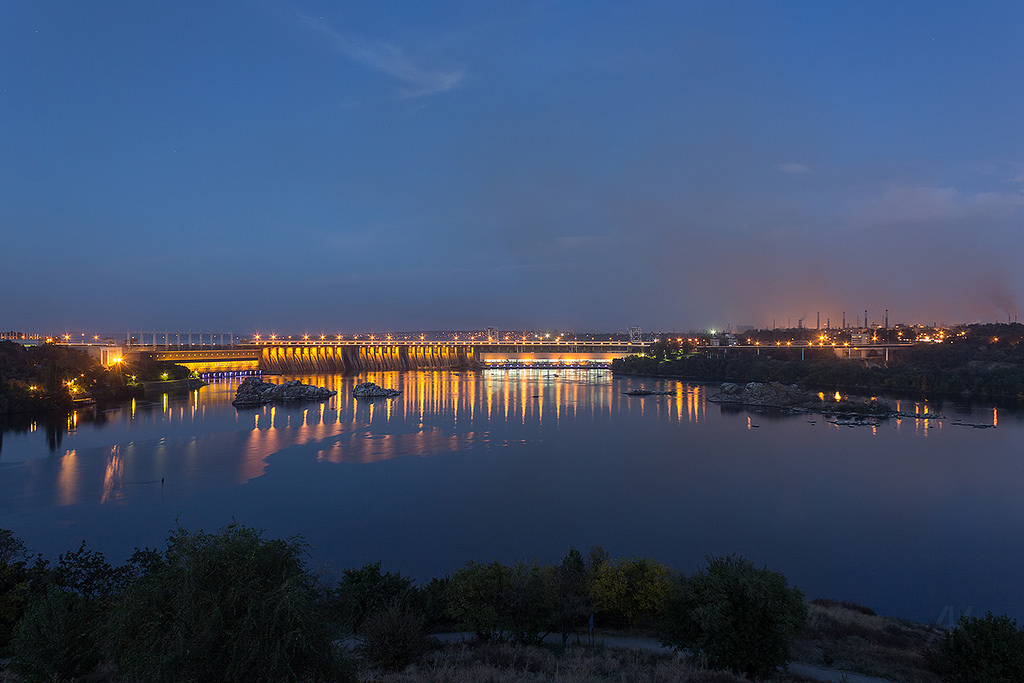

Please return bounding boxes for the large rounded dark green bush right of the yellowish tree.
[662,556,807,678]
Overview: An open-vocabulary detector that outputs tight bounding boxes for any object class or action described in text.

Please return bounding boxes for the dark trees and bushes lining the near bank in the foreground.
[0,524,1011,681]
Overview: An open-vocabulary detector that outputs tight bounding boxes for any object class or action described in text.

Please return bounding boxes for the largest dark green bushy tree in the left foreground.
[110,524,345,681]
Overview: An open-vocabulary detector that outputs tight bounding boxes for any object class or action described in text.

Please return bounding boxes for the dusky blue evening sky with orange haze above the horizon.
[0,0,1024,333]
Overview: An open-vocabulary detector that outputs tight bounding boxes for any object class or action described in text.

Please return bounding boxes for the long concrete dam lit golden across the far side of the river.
[134,340,649,376]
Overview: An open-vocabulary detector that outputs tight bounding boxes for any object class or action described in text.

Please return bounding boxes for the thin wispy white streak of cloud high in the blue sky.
[298,14,466,99]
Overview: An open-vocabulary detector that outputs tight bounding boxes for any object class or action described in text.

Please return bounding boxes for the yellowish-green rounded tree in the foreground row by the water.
[590,558,672,627]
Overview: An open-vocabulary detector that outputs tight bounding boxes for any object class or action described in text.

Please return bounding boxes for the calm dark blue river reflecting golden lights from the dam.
[0,371,1024,624]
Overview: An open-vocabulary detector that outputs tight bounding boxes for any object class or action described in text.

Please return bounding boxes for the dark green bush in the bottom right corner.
[939,612,1024,683]
